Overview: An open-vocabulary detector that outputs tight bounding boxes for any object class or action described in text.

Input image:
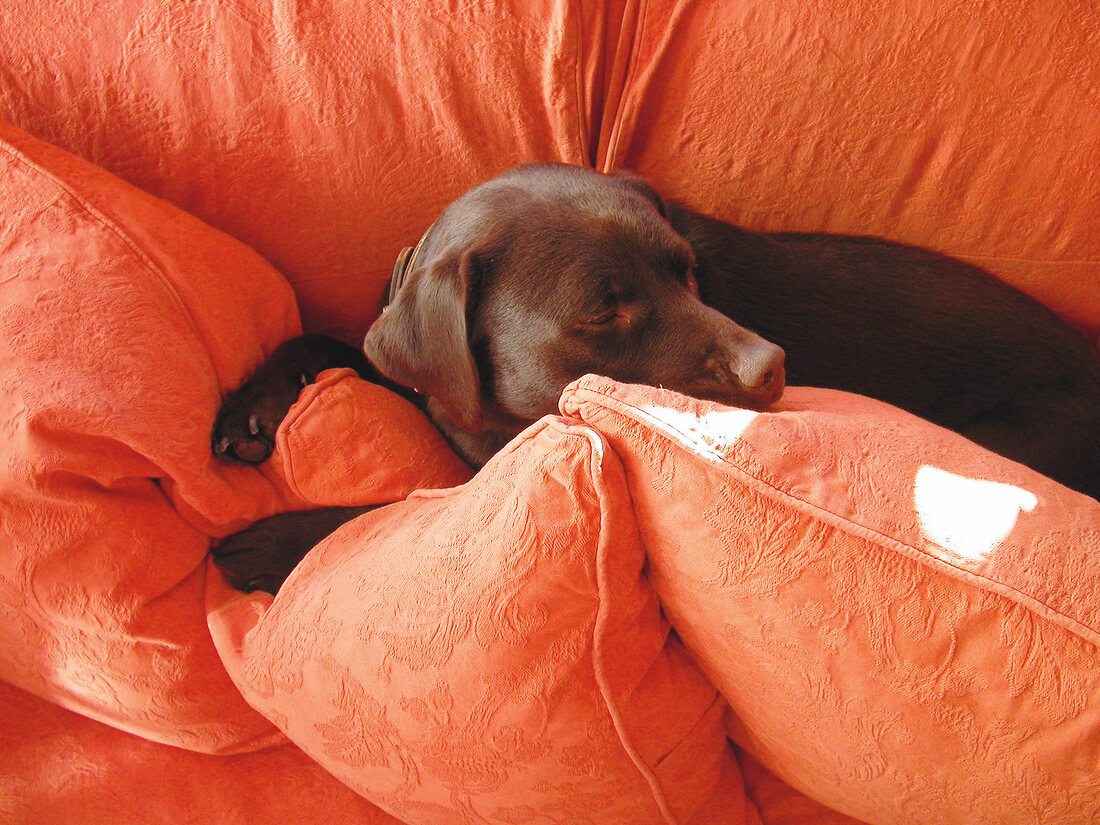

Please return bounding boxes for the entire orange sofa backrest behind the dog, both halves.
[0,0,1100,341]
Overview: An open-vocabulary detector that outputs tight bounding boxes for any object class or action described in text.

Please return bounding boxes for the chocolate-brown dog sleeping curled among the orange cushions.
[215,164,1100,583]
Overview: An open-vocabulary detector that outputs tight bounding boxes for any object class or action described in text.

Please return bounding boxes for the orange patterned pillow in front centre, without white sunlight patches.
[210,419,759,825]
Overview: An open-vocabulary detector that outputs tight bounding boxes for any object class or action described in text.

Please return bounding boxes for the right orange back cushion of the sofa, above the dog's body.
[596,0,1100,339]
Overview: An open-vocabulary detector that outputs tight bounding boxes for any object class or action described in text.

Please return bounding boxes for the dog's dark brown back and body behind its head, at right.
[671,211,1100,498]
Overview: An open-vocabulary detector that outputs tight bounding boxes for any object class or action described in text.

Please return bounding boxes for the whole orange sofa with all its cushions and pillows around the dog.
[0,0,1100,825]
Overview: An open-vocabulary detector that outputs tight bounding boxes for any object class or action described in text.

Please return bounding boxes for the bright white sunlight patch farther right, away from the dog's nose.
[913,464,1038,561]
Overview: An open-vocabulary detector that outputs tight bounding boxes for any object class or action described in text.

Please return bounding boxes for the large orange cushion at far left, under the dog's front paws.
[0,124,469,752]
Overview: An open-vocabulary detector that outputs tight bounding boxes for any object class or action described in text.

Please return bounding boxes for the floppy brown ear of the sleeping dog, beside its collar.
[363,250,482,432]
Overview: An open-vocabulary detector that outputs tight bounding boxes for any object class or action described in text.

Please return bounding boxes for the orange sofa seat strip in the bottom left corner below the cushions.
[0,682,402,825]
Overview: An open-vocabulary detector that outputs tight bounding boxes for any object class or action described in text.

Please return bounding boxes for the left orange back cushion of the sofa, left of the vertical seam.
[0,0,605,341]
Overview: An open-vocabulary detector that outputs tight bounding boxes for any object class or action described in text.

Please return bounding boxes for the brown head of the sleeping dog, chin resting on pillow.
[364,164,784,446]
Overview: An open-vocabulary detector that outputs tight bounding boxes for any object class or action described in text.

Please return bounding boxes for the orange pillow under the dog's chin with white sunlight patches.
[562,376,1100,825]
